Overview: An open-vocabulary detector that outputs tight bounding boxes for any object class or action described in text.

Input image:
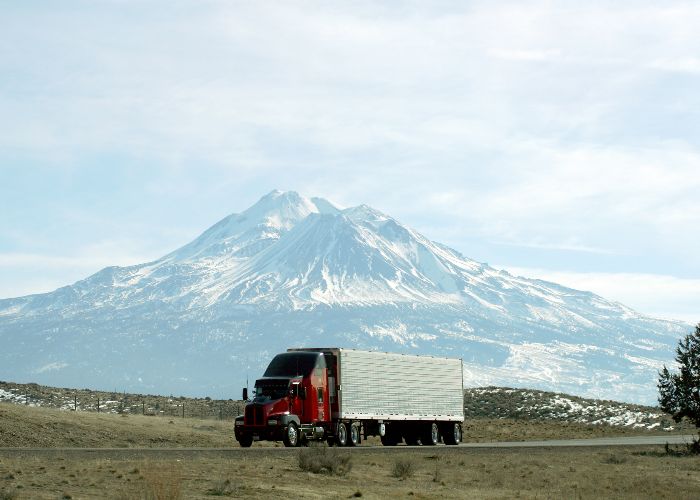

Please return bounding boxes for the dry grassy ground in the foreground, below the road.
[0,446,700,500]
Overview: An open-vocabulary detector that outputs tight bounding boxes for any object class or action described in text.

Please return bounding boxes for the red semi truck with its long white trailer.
[234,347,464,447]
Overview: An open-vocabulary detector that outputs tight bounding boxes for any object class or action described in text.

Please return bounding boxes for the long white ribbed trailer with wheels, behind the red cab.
[288,348,464,446]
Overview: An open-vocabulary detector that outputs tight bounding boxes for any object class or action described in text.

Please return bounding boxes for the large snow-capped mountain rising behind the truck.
[0,191,690,403]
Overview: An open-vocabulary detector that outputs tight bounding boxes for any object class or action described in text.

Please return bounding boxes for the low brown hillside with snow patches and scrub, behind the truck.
[0,382,693,447]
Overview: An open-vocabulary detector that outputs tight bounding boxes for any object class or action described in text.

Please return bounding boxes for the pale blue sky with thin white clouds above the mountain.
[0,0,700,324]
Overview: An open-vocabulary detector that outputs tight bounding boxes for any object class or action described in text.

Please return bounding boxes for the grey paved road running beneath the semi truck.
[0,434,694,458]
